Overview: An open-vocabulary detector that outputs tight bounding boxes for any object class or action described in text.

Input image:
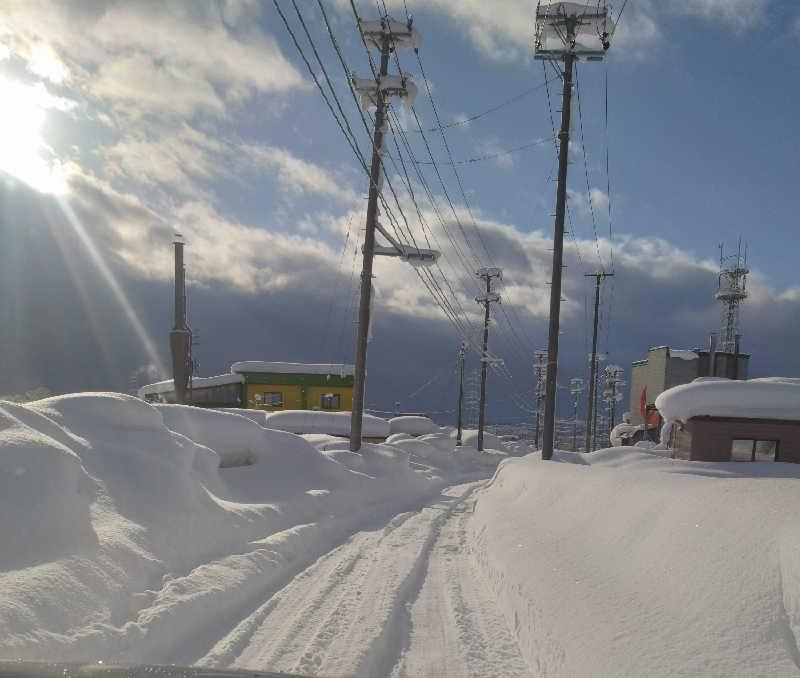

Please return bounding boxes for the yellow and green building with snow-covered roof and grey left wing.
[139,361,355,412]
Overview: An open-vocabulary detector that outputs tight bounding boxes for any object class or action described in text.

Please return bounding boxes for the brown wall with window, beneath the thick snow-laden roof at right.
[670,416,800,464]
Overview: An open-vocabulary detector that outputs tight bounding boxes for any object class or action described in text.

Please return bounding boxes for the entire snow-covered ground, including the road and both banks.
[6,394,800,678]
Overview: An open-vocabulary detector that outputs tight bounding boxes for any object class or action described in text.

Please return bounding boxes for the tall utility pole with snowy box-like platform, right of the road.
[535,2,609,459]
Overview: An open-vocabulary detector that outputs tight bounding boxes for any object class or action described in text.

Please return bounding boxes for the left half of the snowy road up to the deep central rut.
[200,483,479,676]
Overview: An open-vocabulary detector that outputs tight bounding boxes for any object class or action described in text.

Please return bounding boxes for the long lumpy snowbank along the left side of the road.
[0,393,506,669]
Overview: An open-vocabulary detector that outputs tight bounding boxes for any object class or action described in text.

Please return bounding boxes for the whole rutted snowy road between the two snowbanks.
[197,483,530,677]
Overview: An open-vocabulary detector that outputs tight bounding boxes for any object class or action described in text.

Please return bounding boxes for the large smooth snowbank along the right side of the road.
[468,447,800,678]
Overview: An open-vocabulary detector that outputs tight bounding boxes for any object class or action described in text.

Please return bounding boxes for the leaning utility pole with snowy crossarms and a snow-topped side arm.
[350,16,428,452]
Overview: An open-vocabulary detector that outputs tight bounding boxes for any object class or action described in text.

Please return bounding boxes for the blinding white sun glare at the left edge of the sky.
[0,78,67,195]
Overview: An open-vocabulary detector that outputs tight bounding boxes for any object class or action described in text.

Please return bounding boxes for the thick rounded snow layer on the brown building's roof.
[656,377,800,422]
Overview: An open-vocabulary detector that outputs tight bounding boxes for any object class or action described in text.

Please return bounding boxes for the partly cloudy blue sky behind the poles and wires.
[0,0,800,423]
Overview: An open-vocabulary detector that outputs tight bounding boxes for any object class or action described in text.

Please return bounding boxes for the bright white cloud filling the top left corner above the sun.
[0,0,308,116]
